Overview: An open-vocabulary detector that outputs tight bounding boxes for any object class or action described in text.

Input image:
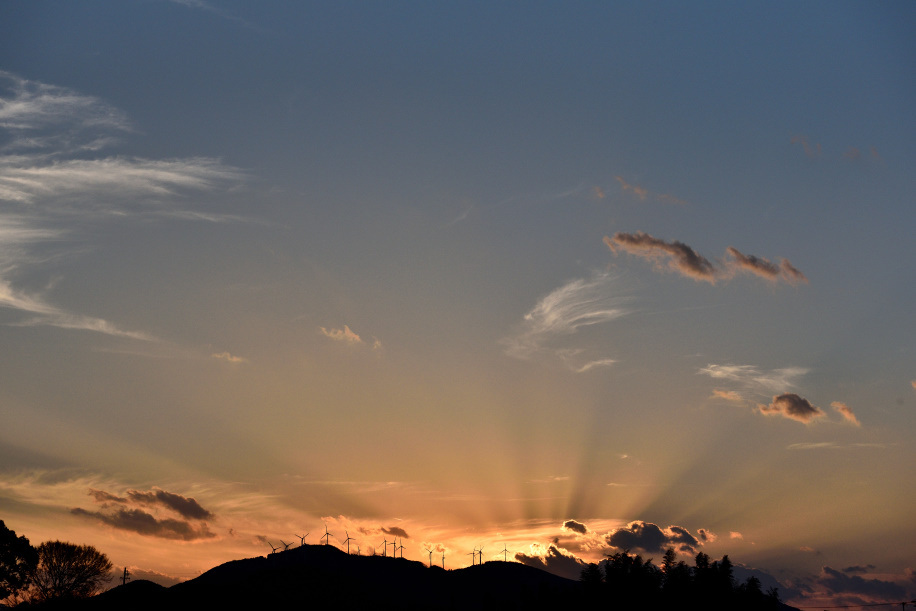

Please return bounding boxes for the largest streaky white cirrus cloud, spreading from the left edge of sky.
[0,71,244,340]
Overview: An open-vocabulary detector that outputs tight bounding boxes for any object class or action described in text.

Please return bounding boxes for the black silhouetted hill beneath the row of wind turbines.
[17,545,790,610]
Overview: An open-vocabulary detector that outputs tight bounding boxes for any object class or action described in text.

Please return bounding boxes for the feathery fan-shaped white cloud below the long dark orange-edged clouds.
[502,273,629,373]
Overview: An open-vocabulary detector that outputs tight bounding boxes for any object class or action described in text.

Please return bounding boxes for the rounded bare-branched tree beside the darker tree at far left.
[34,541,111,600]
